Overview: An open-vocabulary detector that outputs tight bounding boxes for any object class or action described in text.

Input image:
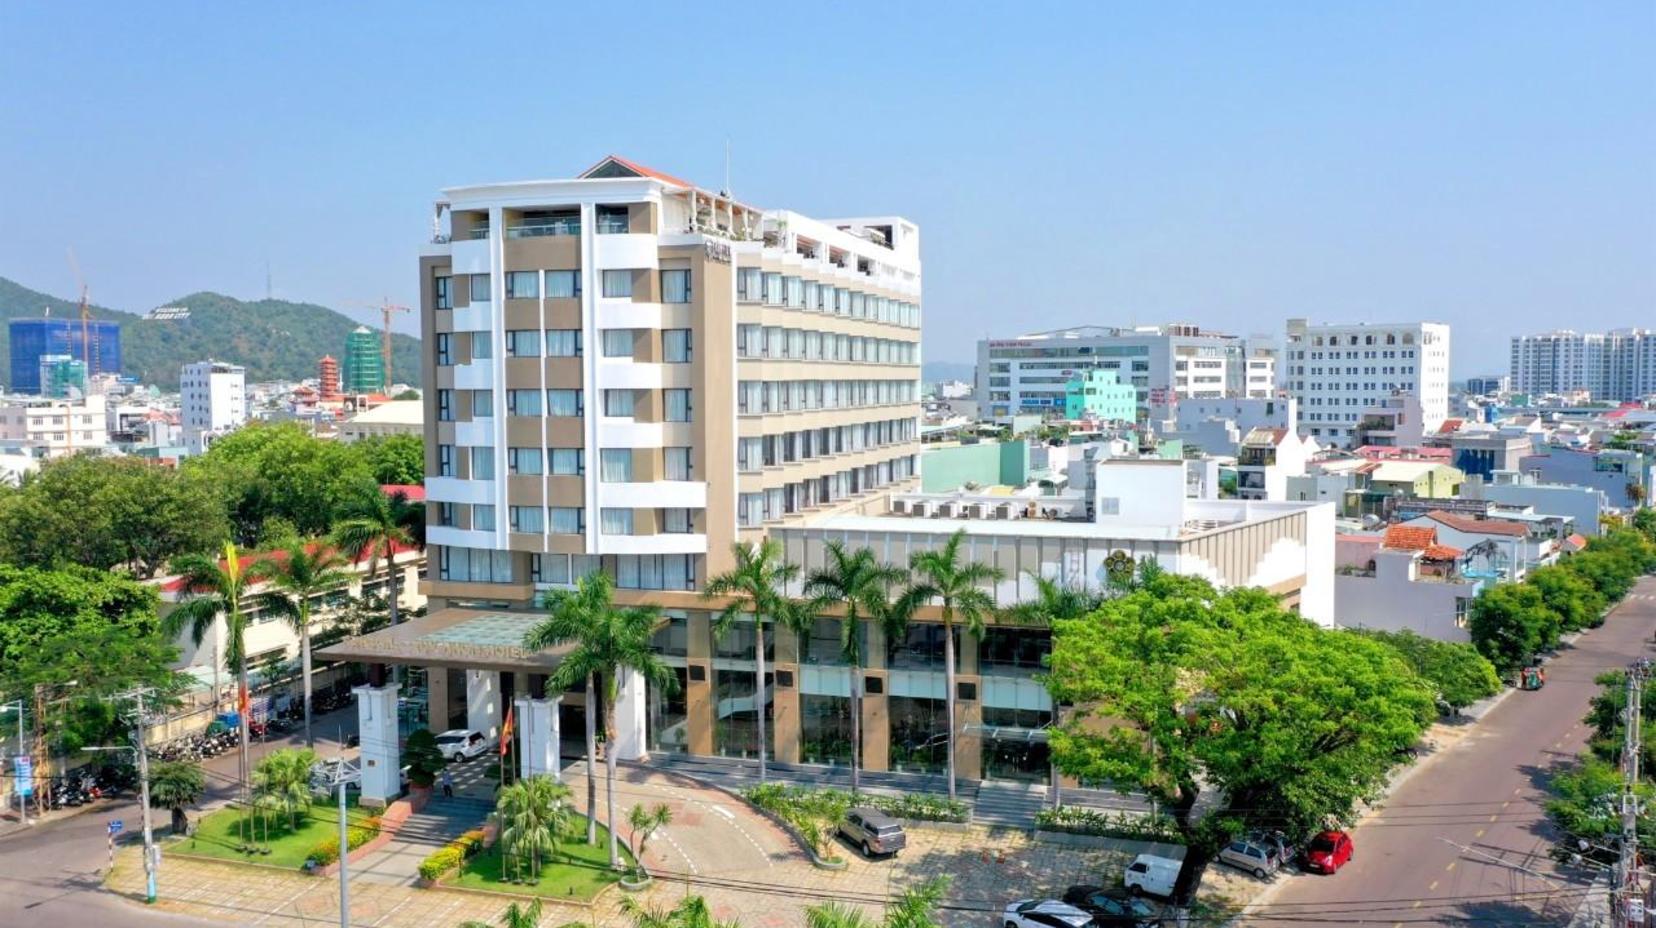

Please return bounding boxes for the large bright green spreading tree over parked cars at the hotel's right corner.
[1047,575,1434,901]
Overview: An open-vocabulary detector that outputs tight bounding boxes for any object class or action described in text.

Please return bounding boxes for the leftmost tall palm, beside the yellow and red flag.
[161,542,270,821]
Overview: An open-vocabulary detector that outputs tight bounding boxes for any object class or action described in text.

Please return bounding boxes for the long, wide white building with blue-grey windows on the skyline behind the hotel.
[977,325,1275,421]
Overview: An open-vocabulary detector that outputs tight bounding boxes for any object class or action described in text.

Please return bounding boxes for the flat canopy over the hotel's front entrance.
[316,608,575,673]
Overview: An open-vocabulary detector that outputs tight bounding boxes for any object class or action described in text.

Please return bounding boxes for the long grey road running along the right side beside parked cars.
[1242,578,1656,928]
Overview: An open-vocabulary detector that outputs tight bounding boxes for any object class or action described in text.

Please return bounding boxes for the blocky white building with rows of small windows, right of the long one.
[1278,318,1449,444]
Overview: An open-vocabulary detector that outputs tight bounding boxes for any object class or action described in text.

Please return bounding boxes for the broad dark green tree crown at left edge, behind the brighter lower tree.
[0,454,229,578]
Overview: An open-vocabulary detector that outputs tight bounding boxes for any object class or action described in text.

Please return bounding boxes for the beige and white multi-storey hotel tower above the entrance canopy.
[421,157,921,608]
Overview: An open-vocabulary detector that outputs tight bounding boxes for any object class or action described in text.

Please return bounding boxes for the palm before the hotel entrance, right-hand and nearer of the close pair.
[523,570,679,870]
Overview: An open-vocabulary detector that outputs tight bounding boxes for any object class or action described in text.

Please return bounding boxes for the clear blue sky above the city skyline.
[0,0,1656,376]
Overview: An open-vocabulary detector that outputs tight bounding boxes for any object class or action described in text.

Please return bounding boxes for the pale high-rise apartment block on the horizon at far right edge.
[1512,328,1656,403]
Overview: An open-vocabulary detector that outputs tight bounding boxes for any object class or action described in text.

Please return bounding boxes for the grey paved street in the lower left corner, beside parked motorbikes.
[0,706,356,928]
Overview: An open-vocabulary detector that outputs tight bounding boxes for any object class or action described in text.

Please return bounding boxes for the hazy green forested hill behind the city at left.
[0,277,421,389]
